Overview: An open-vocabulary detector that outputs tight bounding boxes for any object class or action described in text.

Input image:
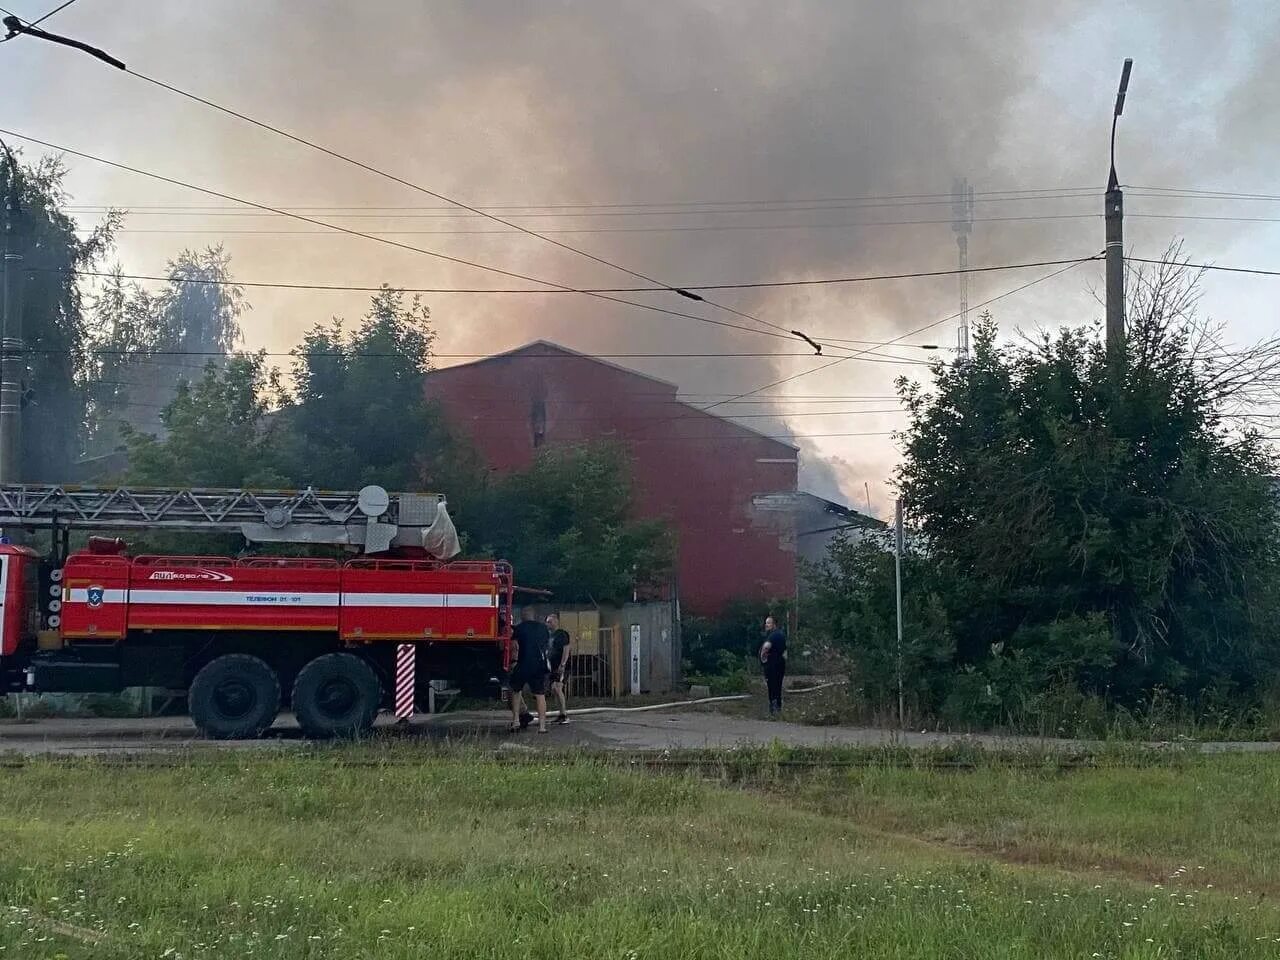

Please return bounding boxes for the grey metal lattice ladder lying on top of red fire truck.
[0,484,457,556]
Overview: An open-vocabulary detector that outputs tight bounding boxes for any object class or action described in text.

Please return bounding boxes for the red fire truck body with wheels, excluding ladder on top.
[0,483,515,739]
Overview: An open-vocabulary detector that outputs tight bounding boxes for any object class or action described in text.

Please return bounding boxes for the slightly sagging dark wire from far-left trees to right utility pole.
[47,257,1100,294]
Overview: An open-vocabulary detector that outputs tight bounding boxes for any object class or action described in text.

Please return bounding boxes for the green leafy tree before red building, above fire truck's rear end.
[458,443,675,603]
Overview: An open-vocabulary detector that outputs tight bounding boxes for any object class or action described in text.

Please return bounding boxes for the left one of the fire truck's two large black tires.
[187,653,280,740]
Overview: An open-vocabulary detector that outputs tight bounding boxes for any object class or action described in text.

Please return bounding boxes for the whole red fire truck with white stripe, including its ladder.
[0,485,515,739]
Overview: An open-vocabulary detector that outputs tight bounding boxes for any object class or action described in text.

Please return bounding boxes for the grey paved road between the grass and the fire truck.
[0,709,1280,755]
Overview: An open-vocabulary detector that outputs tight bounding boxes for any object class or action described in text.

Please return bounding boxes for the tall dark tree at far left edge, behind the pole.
[0,151,119,481]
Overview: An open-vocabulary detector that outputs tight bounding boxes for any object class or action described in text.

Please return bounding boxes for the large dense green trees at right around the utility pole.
[813,264,1280,723]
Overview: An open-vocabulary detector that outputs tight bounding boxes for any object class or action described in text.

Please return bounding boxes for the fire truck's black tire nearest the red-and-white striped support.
[293,653,383,737]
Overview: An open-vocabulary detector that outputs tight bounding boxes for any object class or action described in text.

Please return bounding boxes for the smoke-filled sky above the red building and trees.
[0,0,1280,516]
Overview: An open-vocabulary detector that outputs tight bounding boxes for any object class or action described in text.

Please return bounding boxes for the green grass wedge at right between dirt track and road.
[787,749,1280,897]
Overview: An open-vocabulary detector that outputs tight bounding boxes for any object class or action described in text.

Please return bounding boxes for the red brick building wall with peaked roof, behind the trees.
[426,340,799,614]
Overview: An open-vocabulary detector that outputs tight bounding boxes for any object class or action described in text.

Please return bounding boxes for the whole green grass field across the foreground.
[0,748,1280,960]
